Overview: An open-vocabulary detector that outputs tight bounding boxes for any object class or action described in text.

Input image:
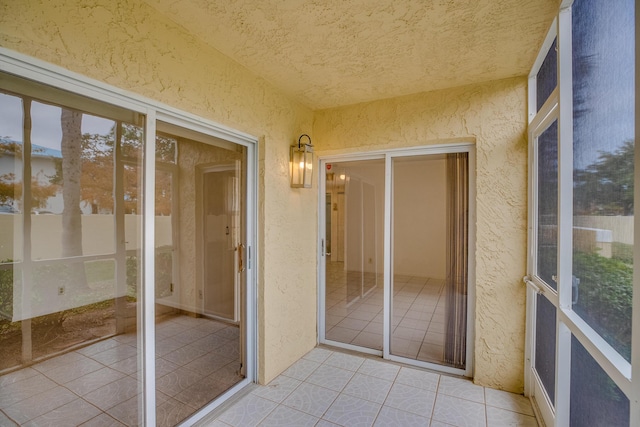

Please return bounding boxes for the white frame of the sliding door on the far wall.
[318,140,476,377]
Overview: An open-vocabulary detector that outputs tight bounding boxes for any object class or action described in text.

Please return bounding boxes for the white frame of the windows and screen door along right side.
[525,0,640,426]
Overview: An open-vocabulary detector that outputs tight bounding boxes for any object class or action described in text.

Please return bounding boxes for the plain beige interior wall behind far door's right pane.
[393,157,447,279]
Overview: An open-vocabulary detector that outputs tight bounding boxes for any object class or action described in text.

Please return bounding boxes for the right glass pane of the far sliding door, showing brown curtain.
[390,153,468,369]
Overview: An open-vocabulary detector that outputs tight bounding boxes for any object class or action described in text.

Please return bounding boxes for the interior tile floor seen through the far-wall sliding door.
[325,262,446,363]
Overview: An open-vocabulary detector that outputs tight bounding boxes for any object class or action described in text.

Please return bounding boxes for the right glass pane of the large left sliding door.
[155,127,246,425]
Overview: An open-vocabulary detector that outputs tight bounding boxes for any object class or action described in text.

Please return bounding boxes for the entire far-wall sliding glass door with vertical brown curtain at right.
[320,145,471,375]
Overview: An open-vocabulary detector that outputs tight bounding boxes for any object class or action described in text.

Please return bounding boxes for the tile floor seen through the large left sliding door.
[0,315,242,427]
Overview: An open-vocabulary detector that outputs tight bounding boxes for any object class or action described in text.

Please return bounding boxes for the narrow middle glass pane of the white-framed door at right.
[535,121,558,289]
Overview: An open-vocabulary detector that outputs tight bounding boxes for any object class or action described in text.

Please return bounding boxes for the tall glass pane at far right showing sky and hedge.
[572,0,635,360]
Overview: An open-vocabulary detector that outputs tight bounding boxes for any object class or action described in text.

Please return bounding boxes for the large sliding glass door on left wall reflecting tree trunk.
[0,61,255,426]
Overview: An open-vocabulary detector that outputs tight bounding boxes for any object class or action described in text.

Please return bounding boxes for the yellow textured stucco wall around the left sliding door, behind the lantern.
[0,0,317,382]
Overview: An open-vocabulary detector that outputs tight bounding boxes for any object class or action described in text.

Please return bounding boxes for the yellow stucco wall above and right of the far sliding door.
[314,78,527,392]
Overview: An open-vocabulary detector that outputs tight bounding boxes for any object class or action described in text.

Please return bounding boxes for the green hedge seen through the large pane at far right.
[573,252,633,360]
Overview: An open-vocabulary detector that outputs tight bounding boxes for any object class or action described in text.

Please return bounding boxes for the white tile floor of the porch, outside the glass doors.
[198,347,538,427]
